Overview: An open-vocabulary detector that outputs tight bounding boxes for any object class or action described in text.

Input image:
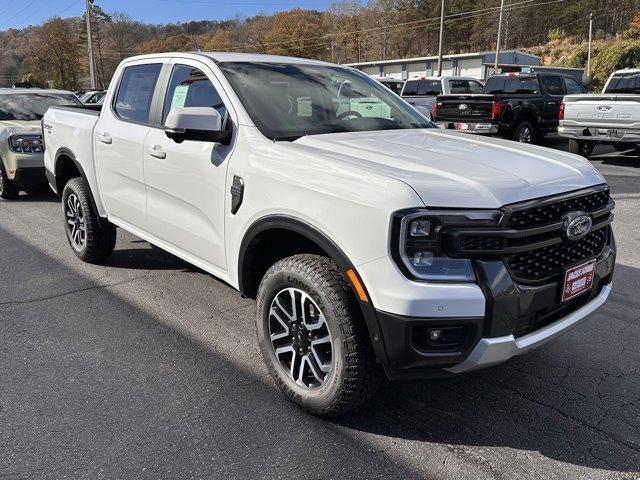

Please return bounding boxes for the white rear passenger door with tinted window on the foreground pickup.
[93,60,162,230]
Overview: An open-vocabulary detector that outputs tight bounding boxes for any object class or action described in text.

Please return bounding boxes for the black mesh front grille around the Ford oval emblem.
[443,185,614,284]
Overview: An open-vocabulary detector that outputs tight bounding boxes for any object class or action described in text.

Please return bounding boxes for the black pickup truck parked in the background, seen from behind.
[435,73,583,143]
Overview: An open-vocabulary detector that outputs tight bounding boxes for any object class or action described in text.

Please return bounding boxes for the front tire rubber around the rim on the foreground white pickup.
[256,255,381,416]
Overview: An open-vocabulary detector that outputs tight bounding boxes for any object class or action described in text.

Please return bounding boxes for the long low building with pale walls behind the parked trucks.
[346,50,540,80]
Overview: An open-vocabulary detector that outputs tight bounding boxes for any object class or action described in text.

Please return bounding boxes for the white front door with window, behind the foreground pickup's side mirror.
[143,60,232,271]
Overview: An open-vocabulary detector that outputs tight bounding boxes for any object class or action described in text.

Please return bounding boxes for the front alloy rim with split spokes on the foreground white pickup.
[269,288,333,389]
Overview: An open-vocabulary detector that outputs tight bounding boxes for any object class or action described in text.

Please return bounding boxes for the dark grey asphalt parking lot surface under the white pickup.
[0,141,640,479]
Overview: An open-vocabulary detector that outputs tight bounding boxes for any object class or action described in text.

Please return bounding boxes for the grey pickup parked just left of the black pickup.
[401,76,484,120]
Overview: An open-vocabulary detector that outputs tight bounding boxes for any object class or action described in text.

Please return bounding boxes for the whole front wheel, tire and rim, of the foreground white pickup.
[257,255,380,416]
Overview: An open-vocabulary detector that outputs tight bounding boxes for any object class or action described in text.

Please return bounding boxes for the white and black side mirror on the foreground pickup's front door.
[164,107,231,145]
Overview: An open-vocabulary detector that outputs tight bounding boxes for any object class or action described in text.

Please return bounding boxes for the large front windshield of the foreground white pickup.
[219,62,433,140]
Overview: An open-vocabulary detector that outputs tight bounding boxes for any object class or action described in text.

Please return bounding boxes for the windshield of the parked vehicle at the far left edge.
[0,93,80,120]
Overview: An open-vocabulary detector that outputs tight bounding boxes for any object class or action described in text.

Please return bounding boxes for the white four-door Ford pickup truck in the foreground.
[43,53,615,415]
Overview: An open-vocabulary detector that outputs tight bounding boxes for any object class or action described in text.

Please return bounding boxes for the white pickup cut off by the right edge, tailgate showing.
[558,68,640,158]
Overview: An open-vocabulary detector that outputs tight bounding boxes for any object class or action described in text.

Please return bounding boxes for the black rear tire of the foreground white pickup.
[62,177,116,263]
